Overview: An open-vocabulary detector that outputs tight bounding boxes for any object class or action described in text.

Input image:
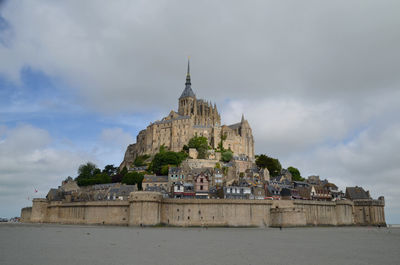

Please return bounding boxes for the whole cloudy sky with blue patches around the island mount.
[0,0,400,224]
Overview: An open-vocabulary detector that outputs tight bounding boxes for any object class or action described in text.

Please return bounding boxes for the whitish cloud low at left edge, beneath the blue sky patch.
[0,125,93,216]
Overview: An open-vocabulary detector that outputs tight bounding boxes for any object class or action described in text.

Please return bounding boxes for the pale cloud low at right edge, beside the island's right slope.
[290,122,400,223]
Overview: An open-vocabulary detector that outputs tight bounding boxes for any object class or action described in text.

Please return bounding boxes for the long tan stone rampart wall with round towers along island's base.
[21,192,386,227]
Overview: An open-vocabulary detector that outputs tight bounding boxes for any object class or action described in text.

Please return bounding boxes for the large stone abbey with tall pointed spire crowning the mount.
[121,62,254,168]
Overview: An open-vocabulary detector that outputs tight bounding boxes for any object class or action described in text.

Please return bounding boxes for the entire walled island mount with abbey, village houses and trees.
[21,62,386,227]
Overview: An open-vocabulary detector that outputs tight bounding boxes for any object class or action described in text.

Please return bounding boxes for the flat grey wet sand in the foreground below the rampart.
[0,224,400,265]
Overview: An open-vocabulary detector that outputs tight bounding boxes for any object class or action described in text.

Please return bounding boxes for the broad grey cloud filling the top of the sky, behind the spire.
[0,0,400,112]
